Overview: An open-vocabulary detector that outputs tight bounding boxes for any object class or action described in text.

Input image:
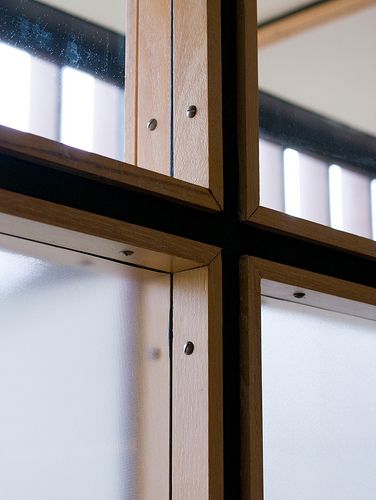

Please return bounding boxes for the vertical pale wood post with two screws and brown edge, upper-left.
[125,0,223,209]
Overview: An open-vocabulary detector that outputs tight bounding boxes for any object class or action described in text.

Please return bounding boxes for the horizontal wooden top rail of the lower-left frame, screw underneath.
[0,189,220,272]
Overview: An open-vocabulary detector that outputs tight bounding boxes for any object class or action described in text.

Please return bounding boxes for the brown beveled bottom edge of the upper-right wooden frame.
[248,207,376,259]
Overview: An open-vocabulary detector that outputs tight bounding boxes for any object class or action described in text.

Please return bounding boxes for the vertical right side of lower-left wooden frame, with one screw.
[172,257,223,500]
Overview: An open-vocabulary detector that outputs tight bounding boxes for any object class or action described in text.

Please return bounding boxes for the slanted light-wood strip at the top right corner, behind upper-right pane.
[258,0,376,49]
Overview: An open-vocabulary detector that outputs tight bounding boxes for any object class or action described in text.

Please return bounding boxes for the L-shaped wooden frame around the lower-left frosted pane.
[0,189,223,500]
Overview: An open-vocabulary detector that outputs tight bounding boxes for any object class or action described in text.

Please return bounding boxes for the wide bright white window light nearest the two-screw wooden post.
[61,67,94,151]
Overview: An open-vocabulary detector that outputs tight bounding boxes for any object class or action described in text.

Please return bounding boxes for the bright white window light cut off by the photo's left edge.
[0,43,31,132]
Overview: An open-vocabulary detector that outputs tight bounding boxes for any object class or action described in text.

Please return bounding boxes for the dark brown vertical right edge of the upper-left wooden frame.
[207,0,224,210]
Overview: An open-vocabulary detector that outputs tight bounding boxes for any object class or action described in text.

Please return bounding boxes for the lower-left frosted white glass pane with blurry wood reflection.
[0,242,169,500]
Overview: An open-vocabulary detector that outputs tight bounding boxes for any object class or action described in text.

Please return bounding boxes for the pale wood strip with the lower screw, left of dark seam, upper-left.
[125,0,171,175]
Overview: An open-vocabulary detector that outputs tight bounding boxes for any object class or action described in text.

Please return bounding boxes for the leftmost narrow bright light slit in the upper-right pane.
[283,148,301,217]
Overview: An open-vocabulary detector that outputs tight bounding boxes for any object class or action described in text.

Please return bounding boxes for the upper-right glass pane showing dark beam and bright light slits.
[257,0,376,238]
